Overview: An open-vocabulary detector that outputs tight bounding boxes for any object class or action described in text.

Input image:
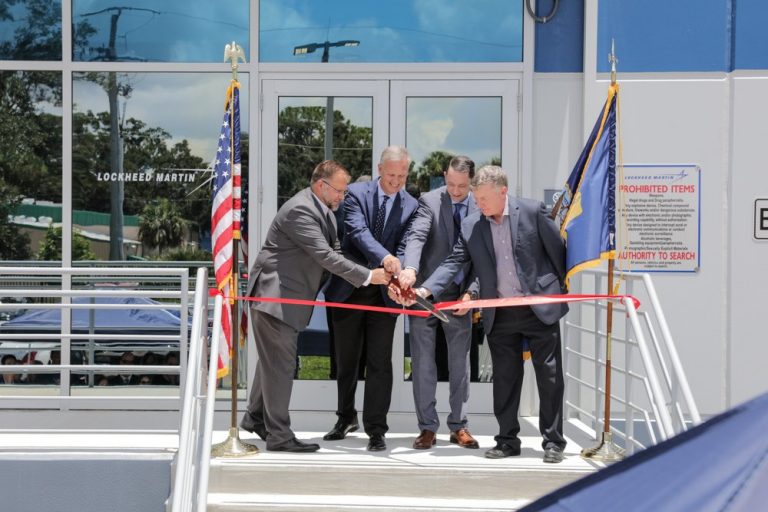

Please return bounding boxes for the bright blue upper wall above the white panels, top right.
[534,0,768,73]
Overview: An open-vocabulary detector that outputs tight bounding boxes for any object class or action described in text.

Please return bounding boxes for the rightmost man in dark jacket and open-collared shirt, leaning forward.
[406,165,568,463]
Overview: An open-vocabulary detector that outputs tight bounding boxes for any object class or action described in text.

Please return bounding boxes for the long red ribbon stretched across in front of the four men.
[208,288,640,317]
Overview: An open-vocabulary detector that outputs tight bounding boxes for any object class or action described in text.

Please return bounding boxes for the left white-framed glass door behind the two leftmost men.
[261,81,387,411]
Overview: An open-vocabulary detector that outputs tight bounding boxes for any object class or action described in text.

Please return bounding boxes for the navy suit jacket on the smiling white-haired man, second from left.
[325,180,418,307]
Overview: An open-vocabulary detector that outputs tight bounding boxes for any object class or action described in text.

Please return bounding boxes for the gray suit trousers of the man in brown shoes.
[408,285,472,432]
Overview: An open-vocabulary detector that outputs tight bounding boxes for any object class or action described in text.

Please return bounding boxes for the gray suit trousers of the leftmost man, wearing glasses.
[247,308,299,449]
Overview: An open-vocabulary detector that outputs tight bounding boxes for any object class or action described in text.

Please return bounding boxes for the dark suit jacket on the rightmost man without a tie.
[423,196,568,333]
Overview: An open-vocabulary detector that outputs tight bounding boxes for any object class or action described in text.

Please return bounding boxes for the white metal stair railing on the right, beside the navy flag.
[563,270,701,452]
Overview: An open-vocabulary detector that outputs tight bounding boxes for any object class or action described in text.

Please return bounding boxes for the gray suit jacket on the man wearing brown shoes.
[403,186,477,301]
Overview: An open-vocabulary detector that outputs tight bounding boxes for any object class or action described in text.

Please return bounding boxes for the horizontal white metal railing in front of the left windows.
[0,265,189,410]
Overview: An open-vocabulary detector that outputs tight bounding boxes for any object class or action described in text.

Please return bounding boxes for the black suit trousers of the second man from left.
[331,285,397,436]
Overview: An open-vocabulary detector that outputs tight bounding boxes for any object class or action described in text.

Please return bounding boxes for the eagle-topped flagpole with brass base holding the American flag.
[211,41,259,457]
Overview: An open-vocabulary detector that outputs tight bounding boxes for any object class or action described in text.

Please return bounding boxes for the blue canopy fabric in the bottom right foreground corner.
[521,394,768,512]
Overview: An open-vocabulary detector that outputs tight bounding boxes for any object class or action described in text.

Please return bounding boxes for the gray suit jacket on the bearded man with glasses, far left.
[248,188,370,331]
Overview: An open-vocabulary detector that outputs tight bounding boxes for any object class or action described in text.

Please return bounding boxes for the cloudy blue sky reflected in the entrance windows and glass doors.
[27,0,523,172]
